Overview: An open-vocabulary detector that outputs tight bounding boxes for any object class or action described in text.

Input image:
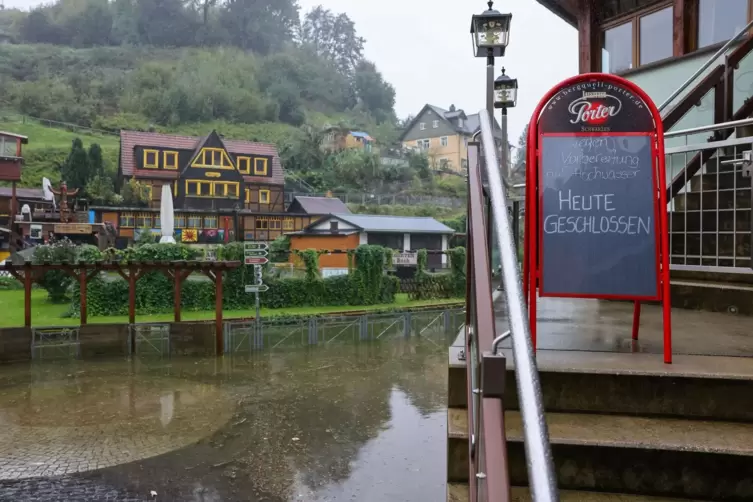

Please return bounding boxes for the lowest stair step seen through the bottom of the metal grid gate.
[669,230,750,259]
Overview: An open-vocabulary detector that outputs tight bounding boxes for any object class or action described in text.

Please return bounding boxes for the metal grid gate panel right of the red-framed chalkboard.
[666,129,753,273]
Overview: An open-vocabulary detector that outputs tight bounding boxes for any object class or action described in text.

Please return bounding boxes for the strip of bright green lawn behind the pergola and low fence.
[0,290,459,327]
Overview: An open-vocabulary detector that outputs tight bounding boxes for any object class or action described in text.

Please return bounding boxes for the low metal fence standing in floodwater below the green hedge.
[224,309,465,354]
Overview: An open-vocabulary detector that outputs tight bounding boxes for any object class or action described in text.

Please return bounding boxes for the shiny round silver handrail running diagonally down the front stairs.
[479,110,559,502]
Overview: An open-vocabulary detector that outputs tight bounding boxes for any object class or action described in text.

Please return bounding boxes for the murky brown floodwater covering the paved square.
[0,335,449,502]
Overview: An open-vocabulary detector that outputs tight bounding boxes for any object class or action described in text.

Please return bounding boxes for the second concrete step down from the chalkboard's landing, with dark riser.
[505,410,753,501]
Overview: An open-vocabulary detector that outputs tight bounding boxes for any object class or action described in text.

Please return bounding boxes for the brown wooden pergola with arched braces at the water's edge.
[0,261,241,354]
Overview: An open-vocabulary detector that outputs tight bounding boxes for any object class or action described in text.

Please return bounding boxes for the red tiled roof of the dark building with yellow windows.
[120,131,285,185]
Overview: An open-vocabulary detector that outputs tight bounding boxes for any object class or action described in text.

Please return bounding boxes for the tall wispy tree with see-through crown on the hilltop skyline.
[301,5,365,76]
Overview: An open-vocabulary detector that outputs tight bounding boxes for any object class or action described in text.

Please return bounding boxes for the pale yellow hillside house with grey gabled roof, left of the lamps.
[399,104,496,172]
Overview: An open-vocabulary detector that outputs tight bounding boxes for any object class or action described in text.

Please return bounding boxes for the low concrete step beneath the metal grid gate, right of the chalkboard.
[671,278,753,316]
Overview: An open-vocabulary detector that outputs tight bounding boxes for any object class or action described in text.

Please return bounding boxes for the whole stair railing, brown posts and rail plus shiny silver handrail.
[466,111,559,502]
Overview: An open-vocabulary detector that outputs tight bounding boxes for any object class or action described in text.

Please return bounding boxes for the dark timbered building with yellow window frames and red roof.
[92,131,320,247]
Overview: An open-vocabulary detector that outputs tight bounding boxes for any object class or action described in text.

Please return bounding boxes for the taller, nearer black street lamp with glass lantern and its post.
[471,0,512,116]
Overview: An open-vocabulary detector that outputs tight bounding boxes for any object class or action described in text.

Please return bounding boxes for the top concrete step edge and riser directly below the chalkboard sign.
[503,352,753,422]
